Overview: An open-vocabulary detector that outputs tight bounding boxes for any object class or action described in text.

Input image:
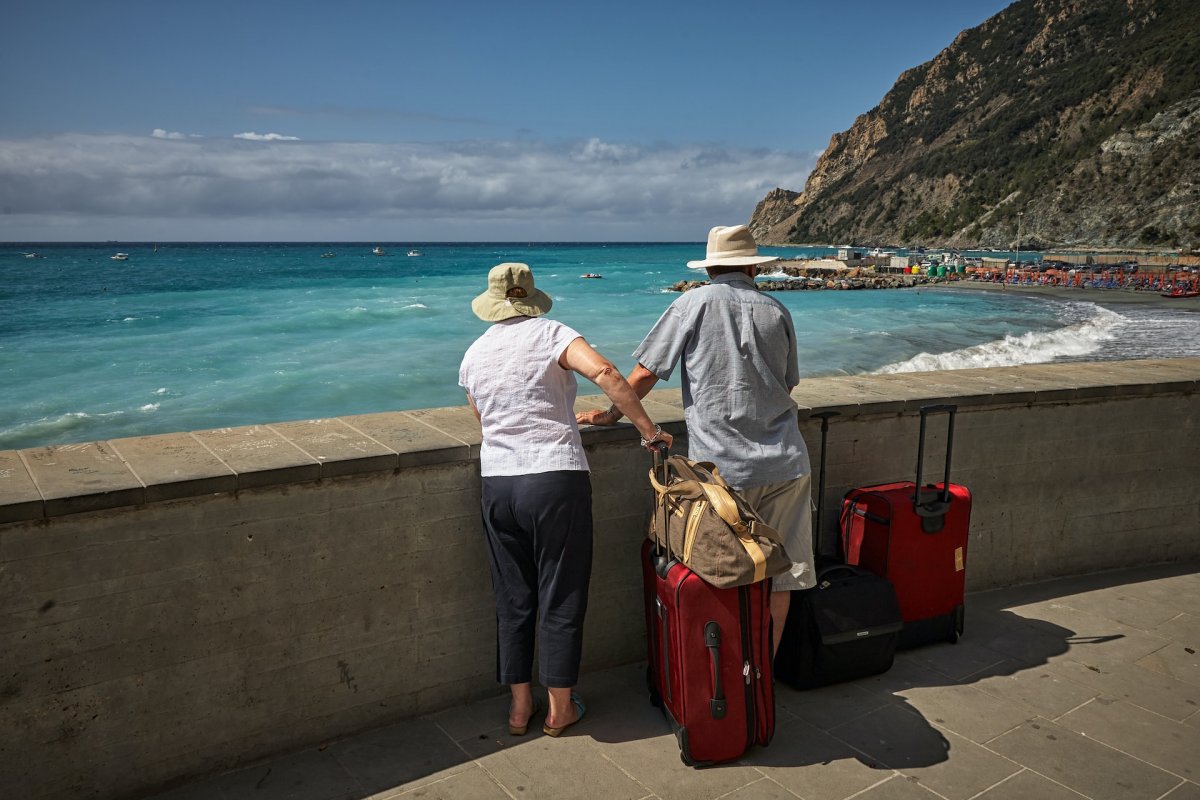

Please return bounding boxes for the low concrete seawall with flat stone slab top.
[0,359,1200,798]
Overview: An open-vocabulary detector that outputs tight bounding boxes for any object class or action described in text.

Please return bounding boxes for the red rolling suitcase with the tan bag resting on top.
[642,448,775,766]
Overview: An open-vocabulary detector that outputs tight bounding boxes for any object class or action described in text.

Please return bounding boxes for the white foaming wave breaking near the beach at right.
[875,306,1128,374]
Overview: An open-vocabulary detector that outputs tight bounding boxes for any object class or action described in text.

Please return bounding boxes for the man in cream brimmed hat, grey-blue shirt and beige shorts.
[577,225,814,648]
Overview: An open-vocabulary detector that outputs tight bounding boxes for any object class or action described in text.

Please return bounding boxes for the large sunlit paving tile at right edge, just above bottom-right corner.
[1055,697,1200,781]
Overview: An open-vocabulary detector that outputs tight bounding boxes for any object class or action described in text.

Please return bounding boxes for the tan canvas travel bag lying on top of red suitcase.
[647,456,792,589]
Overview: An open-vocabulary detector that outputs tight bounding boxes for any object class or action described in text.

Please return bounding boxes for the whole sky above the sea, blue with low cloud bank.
[0,0,1008,241]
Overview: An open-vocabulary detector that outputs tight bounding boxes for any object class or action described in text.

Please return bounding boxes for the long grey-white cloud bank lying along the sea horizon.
[0,132,814,241]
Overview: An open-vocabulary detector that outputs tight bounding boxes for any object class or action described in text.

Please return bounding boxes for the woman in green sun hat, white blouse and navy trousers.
[458,264,671,736]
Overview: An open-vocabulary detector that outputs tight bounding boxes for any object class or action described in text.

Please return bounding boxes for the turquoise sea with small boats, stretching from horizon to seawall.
[0,237,1200,449]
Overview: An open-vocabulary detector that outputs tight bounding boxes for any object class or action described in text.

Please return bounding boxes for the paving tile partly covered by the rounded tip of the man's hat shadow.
[829,705,1020,800]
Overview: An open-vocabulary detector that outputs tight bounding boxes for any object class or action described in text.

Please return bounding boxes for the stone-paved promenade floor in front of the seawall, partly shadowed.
[150,564,1200,800]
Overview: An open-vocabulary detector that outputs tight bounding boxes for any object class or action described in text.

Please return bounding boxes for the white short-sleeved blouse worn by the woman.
[458,317,588,477]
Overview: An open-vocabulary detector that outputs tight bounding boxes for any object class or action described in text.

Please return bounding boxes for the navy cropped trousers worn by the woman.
[482,470,592,688]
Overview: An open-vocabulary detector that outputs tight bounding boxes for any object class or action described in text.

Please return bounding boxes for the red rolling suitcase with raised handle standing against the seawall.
[841,405,971,648]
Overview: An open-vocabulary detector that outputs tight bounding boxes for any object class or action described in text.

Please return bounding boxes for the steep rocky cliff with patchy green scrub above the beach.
[750,0,1200,248]
